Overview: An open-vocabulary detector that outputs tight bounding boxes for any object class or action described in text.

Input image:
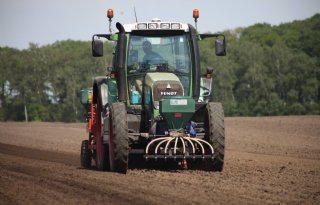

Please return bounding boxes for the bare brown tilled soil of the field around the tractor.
[0,116,320,205]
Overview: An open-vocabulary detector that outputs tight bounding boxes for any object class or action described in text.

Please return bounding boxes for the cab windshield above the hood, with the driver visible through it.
[127,34,191,99]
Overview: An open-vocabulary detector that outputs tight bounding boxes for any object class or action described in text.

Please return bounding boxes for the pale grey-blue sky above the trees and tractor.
[0,0,320,49]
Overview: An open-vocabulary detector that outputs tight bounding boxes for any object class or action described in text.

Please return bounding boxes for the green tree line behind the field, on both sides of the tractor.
[0,14,320,122]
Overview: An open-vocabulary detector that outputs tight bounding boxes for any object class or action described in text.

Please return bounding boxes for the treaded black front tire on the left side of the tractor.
[109,102,129,174]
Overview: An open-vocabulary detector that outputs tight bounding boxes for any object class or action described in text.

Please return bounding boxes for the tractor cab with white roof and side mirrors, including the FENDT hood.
[92,16,225,117]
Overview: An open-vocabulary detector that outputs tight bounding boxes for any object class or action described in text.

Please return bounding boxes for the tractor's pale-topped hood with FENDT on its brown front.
[145,72,184,109]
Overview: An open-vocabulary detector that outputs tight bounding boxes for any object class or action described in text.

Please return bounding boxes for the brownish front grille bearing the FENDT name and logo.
[153,81,183,101]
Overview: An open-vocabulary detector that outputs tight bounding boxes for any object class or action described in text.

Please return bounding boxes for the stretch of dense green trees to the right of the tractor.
[200,14,320,116]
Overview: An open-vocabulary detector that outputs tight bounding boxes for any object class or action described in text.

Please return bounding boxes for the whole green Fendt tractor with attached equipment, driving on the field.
[81,9,226,173]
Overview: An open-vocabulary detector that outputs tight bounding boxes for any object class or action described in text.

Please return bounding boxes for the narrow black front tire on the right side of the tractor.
[207,102,225,172]
